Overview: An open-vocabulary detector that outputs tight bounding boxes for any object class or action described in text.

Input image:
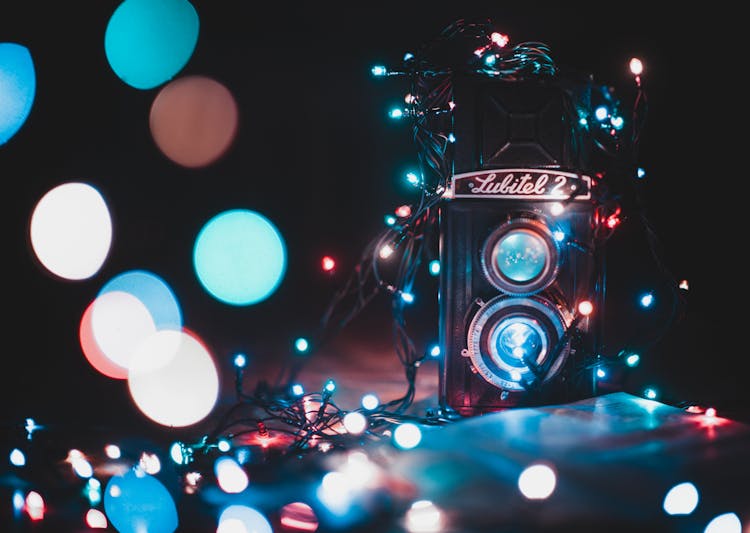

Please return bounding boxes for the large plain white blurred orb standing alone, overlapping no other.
[29,182,112,280]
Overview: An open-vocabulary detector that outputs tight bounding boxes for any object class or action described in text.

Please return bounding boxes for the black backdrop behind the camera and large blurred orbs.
[0,0,749,446]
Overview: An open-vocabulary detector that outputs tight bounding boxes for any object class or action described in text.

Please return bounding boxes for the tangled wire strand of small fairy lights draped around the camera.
[192,17,684,458]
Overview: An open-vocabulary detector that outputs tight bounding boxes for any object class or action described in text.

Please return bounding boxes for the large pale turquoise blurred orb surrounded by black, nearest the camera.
[193,209,287,306]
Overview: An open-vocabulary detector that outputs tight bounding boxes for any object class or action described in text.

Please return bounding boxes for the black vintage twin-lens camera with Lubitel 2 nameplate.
[438,74,603,415]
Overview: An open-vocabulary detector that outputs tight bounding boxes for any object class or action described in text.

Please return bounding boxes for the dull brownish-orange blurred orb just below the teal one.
[149,76,239,168]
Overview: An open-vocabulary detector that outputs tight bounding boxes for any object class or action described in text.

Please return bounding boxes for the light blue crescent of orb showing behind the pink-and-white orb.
[99,270,182,330]
